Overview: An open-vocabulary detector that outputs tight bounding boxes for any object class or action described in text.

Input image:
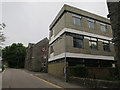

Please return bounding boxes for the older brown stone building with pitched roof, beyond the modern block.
[25,38,49,72]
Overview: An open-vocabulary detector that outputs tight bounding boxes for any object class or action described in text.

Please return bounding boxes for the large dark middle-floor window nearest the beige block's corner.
[73,37,84,48]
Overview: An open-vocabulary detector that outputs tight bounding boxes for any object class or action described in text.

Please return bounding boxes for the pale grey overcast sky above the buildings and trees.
[0,0,108,46]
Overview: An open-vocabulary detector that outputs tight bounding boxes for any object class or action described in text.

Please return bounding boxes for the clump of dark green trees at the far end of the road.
[2,43,26,68]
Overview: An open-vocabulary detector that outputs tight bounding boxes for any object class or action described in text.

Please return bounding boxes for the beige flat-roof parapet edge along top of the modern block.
[49,4,110,30]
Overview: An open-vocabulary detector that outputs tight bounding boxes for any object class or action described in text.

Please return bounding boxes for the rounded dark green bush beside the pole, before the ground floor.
[70,65,88,78]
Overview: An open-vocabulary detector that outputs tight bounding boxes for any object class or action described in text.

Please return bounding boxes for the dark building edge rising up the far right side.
[107,0,120,68]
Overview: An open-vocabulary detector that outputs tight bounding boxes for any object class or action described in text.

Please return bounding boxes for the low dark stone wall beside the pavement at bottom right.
[69,77,120,88]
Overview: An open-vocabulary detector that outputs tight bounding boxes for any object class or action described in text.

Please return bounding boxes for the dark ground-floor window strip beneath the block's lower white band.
[49,58,113,67]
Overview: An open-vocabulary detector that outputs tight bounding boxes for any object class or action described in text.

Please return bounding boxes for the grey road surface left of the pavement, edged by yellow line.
[2,69,60,88]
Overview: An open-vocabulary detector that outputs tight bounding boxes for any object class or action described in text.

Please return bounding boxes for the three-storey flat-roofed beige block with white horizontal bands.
[48,5,115,77]
